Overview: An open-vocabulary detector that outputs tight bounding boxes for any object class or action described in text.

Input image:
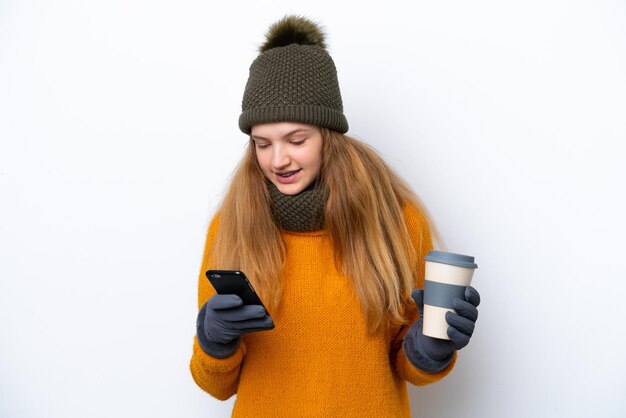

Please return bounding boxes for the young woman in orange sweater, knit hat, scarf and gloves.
[191,16,480,417]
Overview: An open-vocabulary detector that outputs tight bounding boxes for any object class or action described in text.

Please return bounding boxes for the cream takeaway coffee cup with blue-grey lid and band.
[422,251,478,340]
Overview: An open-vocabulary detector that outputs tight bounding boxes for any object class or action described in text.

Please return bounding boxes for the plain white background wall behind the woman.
[0,0,626,418]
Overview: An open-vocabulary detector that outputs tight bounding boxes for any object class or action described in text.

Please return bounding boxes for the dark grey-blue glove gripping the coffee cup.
[403,286,480,372]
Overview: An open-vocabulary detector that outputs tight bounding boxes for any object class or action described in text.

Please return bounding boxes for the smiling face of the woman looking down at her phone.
[251,122,322,195]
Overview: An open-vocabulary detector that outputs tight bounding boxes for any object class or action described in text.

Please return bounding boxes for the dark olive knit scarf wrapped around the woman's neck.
[268,180,326,232]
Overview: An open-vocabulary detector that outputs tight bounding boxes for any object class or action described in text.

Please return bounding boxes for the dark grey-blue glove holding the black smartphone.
[196,294,274,358]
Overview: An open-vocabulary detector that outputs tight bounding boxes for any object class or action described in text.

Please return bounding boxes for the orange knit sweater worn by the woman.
[190,207,456,418]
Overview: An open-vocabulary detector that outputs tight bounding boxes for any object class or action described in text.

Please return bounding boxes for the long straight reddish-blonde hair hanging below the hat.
[210,128,439,332]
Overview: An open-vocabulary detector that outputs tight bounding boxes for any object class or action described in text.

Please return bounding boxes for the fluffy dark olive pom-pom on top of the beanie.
[259,15,326,54]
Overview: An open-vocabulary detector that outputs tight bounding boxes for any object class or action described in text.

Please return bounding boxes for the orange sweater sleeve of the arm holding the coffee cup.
[390,205,457,386]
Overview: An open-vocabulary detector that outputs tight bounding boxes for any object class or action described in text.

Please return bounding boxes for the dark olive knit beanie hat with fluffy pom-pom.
[239,16,348,135]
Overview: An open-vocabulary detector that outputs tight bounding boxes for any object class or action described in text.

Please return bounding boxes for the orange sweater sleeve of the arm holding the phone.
[190,215,246,400]
